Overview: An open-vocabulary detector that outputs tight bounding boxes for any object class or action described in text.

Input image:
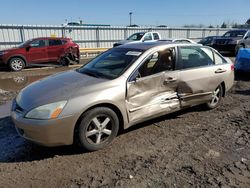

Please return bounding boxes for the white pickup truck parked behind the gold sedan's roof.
[113,32,161,47]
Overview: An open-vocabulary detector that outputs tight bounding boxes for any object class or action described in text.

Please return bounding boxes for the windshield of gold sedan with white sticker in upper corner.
[76,48,143,79]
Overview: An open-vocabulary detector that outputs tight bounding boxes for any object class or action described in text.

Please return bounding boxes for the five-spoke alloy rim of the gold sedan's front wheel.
[85,115,112,144]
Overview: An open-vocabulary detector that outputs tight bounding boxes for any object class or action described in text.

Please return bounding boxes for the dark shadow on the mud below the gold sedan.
[0,106,205,163]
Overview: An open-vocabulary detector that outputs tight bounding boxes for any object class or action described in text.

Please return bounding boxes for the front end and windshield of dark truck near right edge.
[211,29,247,54]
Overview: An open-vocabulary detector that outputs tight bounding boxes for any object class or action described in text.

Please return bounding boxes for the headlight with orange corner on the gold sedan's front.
[25,101,67,119]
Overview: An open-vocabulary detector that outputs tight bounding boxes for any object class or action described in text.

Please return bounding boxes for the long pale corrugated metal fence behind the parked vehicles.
[0,25,229,49]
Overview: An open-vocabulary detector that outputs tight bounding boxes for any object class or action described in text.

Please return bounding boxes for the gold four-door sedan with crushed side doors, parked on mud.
[11,42,234,151]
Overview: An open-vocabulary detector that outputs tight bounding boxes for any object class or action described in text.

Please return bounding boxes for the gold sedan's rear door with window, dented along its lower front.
[177,46,228,107]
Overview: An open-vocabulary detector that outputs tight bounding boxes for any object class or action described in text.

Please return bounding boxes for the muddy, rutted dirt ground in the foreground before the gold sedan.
[0,63,250,188]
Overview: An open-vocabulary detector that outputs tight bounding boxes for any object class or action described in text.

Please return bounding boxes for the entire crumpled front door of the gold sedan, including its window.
[126,49,180,122]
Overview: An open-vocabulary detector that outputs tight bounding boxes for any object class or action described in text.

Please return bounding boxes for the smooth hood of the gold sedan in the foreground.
[16,70,109,111]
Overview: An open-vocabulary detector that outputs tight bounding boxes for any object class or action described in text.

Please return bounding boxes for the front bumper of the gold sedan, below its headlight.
[11,111,75,146]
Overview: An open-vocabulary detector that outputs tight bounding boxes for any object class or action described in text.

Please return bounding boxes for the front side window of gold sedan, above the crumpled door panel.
[138,49,174,77]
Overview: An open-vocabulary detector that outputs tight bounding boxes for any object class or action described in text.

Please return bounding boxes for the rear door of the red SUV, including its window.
[48,39,65,62]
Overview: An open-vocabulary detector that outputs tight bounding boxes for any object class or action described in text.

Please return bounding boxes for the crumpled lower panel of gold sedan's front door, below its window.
[126,72,180,122]
